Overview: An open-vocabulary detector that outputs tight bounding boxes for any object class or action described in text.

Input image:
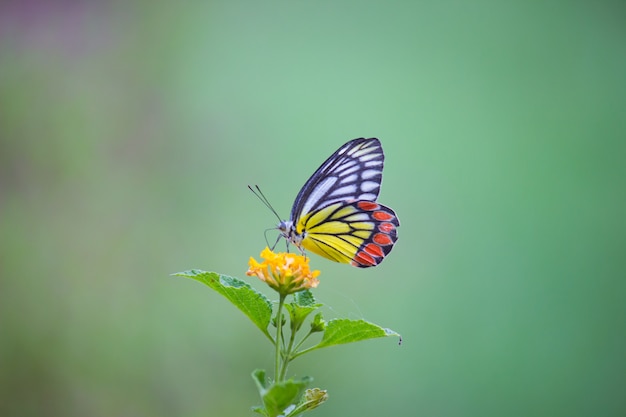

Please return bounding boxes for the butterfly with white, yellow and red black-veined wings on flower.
[255,138,400,268]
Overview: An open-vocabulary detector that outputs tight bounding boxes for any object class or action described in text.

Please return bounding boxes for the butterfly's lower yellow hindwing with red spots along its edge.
[296,200,400,268]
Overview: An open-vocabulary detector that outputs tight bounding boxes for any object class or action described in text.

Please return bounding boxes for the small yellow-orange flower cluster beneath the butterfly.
[246,247,320,295]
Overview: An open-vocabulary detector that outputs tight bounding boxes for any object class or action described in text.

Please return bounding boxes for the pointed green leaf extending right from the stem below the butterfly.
[306,319,400,356]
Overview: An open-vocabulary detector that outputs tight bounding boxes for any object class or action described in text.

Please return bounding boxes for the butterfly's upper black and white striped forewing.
[291,138,385,223]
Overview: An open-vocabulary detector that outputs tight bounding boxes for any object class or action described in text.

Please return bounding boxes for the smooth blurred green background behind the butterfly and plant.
[0,0,626,417]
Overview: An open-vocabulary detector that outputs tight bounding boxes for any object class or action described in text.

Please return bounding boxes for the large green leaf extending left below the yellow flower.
[173,269,274,343]
